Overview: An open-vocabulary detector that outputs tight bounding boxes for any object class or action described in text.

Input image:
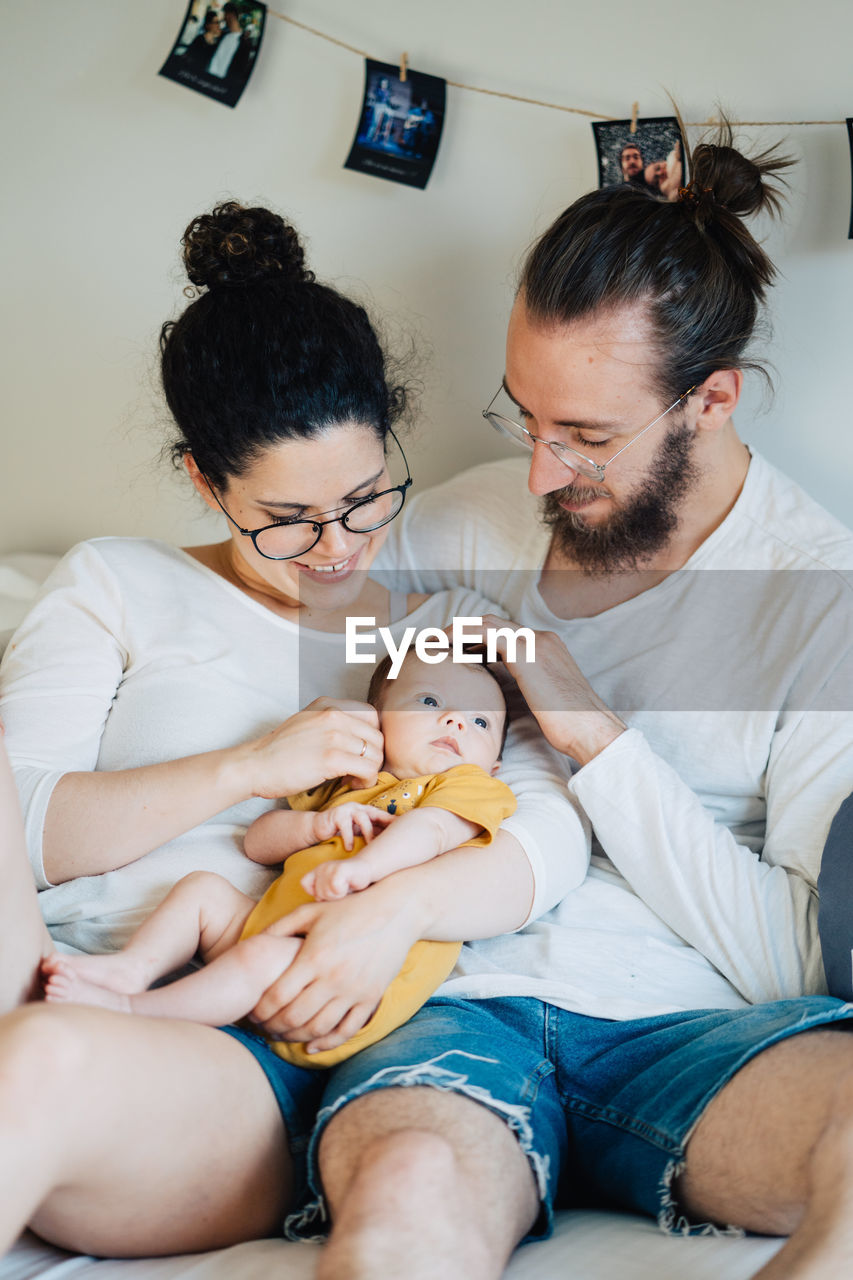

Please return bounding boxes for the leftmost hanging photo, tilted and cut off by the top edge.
[160,0,266,106]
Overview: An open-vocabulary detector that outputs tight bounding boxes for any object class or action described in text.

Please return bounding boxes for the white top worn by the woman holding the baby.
[0,538,589,952]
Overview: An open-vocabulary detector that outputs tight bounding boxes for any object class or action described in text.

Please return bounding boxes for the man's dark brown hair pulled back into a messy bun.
[520,104,793,403]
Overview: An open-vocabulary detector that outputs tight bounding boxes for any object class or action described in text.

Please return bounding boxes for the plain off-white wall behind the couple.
[0,0,853,550]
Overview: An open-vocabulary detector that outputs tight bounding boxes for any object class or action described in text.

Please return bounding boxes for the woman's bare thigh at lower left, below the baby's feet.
[0,1004,298,1257]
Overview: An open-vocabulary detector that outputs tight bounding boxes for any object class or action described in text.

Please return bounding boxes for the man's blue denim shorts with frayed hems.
[284,996,853,1240]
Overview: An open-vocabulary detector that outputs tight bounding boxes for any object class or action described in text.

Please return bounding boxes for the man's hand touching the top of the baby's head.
[483,613,626,765]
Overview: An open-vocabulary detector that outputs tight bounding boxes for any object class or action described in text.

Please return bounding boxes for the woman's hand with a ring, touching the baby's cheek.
[238,698,383,800]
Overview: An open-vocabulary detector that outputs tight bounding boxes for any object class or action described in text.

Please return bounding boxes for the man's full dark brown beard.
[542,424,699,575]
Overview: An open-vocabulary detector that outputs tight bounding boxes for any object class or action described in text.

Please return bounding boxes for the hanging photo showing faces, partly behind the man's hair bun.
[593,115,688,200]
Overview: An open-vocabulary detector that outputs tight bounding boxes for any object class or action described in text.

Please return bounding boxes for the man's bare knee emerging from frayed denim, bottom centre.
[312,1087,539,1280]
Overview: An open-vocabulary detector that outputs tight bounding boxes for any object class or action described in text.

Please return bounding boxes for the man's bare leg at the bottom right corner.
[675,1029,853,1280]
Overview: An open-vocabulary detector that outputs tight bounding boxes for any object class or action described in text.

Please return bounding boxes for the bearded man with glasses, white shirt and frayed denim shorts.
[280,136,853,1280]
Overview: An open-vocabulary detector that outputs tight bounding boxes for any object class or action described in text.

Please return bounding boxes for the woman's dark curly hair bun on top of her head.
[182,200,314,289]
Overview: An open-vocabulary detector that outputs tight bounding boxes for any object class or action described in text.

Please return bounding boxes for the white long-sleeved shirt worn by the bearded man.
[378,456,853,1019]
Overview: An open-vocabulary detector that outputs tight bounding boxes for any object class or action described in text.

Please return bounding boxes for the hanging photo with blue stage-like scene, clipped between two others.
[345,58,446,188]
